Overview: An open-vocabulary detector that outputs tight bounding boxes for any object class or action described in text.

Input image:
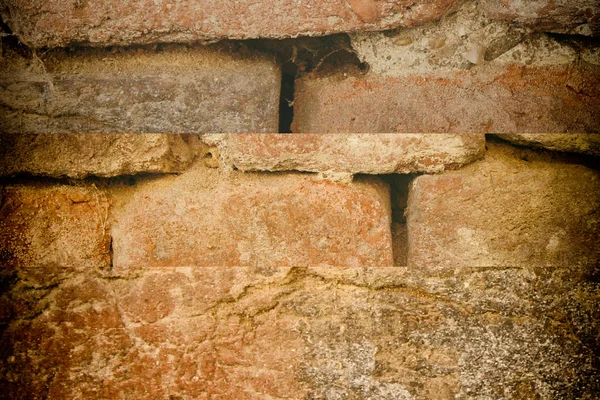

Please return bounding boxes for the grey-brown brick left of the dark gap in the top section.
[0,45,281,133]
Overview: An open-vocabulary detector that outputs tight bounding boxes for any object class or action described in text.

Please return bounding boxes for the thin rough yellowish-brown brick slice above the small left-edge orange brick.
[0,134,207,178]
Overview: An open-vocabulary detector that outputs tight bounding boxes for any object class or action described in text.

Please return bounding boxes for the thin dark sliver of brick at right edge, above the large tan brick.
[498,133,600,156]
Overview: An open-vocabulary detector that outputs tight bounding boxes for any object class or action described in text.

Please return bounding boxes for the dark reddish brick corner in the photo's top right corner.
[483,0,600,36]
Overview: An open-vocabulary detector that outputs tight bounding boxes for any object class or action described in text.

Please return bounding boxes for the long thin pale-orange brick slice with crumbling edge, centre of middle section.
[212,134,485,174]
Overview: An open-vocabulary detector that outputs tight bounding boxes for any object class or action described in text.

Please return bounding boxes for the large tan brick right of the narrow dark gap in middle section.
[407,142,600,268]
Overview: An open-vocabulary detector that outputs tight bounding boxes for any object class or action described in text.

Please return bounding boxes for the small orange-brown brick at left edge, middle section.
[0,185,110,280]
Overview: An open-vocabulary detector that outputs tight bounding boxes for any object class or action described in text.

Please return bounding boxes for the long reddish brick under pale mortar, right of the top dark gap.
[292,64,600,133]
